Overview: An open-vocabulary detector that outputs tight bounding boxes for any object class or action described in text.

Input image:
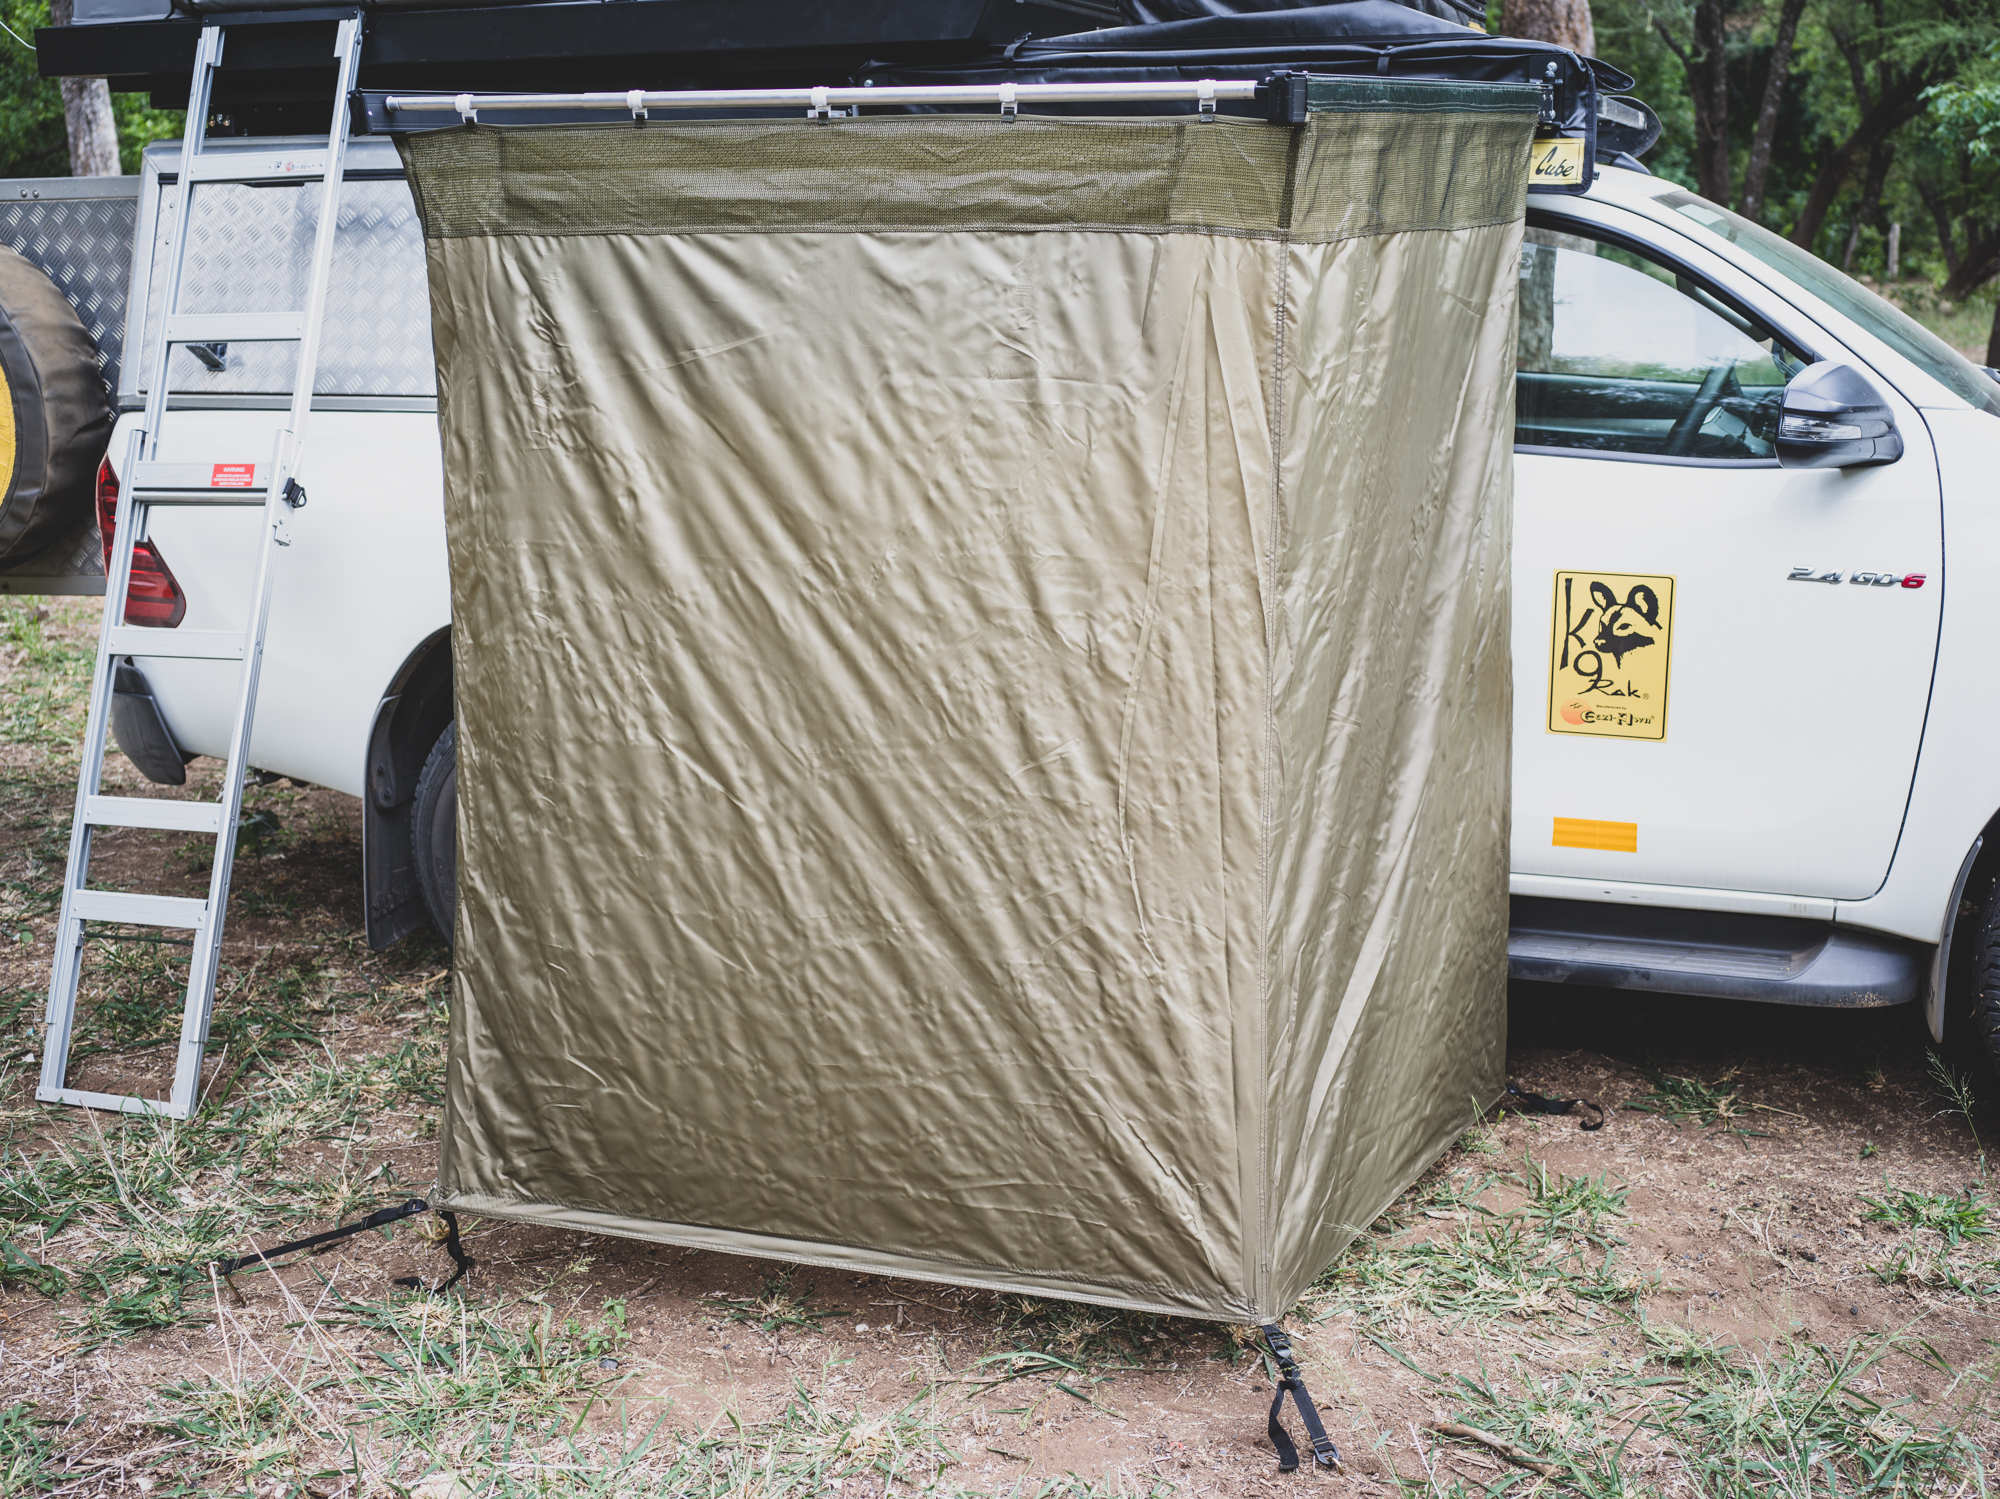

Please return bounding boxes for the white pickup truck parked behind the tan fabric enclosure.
[23,128,2000,1059]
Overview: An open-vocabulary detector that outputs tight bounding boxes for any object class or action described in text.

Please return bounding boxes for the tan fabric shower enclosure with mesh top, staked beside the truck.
[404,80,1536,1321]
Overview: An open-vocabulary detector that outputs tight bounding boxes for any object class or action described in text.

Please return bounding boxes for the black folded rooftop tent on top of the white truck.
[36,0,1656,166]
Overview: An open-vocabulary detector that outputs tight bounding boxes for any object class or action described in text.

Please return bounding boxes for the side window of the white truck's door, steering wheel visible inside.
[1514,228,1810,462]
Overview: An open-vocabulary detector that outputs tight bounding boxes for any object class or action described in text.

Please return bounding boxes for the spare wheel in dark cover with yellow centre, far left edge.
[0,248,112,558]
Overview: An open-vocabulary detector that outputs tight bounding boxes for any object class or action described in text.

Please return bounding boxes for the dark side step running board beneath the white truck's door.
[1506,895,1930,1009]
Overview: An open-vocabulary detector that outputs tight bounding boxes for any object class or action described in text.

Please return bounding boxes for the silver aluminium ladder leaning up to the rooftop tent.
[36,12,362,1119]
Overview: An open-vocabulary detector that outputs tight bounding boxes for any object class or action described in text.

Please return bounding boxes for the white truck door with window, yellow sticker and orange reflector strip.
[1514,226,1944,899]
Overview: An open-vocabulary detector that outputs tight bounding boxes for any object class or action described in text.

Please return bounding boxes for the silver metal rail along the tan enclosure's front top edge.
[370,78,1260,130]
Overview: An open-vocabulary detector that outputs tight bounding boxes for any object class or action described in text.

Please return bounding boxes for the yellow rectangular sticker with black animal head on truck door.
[1548,572,1674,740]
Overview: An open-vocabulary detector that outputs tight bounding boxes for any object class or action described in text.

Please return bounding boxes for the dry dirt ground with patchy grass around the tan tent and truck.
[0,602,2000,1499]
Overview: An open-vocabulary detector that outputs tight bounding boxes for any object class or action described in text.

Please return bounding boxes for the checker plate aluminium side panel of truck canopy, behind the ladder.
[118,140,436,406]
